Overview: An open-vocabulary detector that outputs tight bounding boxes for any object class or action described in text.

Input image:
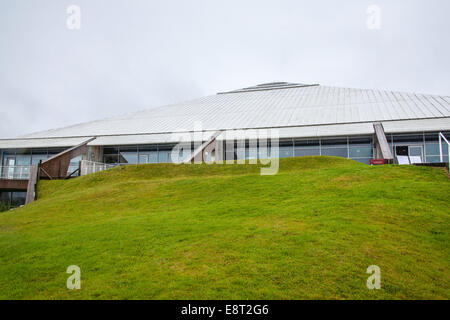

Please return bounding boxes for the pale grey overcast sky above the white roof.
[0,0,450,138]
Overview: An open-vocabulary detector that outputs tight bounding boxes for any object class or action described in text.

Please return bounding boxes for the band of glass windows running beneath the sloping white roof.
[0,132,450,206]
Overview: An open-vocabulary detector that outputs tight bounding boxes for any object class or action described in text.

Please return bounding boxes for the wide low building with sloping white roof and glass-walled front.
[0,82,450,204]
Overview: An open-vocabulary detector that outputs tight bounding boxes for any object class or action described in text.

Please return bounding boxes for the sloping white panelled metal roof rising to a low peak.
[0,83,450,147]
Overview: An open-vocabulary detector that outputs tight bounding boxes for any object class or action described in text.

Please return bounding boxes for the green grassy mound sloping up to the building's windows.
[0,157,450,299]
